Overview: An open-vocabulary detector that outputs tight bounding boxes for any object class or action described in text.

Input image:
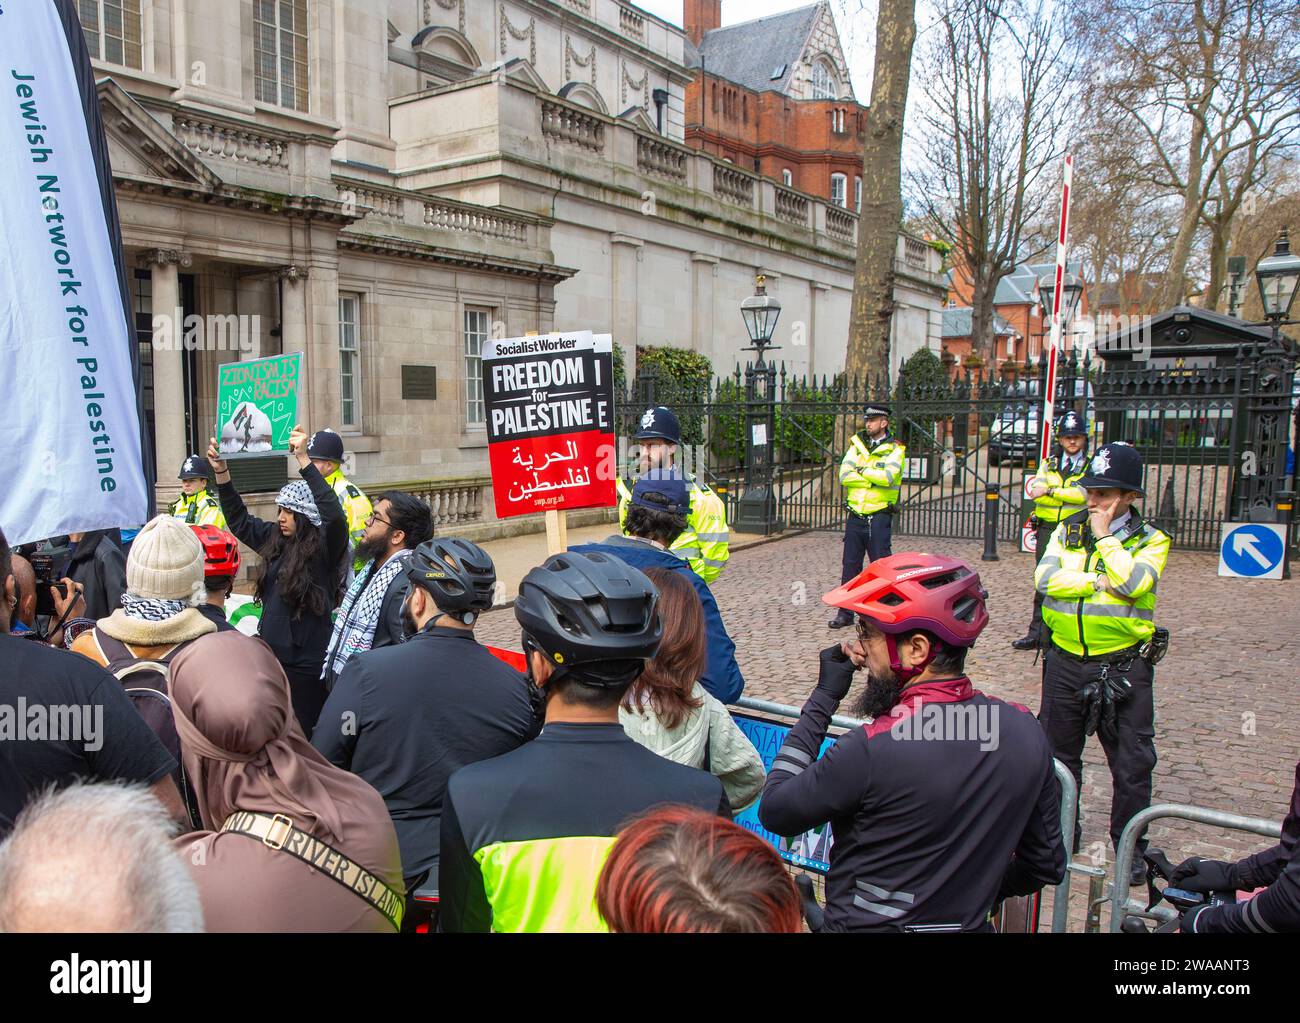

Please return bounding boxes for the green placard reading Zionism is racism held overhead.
[217,352,303,459]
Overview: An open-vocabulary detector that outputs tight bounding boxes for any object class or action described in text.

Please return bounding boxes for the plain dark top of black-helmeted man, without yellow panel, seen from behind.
[312,625,537,879]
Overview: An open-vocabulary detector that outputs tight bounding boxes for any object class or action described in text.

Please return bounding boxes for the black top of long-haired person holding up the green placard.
[217,463,347,675]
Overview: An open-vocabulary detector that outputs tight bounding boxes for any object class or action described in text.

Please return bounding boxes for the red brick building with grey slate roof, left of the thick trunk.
[683,0,867,212]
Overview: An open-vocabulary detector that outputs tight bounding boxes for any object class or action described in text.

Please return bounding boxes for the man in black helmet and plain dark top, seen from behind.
[312,535,537,926]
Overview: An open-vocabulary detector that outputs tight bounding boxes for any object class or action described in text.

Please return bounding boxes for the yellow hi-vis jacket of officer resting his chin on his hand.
[1034,520,1169,656]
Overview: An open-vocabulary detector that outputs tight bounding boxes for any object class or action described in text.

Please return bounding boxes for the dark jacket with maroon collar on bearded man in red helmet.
[758,679,1066,931]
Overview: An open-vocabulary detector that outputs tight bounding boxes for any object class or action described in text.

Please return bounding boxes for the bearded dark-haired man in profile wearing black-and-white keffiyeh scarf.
[321,490,433,692]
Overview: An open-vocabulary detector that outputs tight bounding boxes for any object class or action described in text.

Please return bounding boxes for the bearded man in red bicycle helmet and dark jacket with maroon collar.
[758,554,1066,931]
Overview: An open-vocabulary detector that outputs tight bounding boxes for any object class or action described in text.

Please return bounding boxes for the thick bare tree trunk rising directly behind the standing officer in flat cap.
[845,0,917,391]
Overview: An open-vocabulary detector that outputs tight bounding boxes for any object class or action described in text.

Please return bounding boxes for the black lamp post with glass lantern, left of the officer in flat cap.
[736,274,784,536]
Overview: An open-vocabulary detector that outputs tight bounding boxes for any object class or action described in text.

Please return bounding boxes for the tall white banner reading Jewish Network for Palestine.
[0,1,147,543]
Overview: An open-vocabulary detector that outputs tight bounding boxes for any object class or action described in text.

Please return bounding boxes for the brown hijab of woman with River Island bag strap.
[170,632,397,880]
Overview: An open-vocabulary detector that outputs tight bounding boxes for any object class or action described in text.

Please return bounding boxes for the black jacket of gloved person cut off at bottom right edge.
[1196,763,1300,935]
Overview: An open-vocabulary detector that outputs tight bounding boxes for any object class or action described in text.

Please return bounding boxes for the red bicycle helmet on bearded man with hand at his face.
[822,554,988,646]
